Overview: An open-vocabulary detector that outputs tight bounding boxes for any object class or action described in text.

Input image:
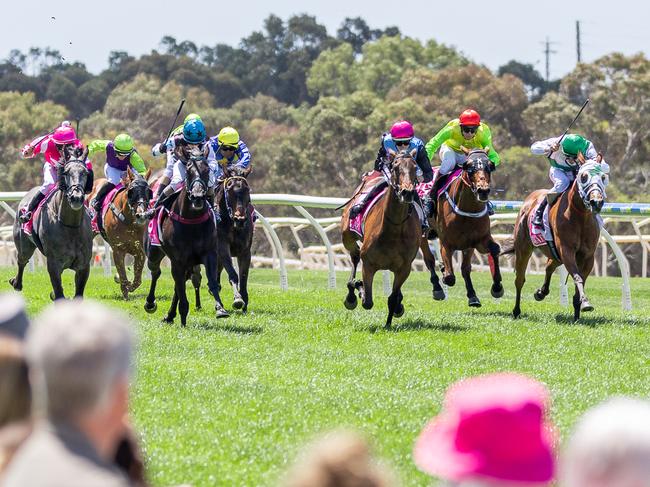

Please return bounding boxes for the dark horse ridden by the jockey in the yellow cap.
[215,167,254,312]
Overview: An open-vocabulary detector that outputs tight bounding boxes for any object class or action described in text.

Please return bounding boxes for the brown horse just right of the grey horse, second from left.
[88,168,153,299]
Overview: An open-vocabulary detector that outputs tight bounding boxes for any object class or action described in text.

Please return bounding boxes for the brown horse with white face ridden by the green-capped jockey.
[503,154,606,321]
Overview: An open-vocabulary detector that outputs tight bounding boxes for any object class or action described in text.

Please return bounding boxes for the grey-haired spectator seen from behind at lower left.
[4,300,133,487]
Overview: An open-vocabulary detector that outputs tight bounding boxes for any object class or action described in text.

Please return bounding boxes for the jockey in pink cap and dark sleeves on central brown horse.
[349,120,433,219]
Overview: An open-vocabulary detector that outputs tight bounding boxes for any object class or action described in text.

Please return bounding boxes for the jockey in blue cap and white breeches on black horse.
[149,119,216,216]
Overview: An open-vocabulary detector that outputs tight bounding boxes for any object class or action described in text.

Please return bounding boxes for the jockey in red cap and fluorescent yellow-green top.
[426,109,501,215]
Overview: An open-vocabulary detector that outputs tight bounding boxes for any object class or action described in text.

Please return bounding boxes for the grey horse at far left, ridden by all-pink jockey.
[9,145,93,299]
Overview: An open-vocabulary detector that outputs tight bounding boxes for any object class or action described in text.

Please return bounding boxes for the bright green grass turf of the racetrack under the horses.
[0,268,650,486]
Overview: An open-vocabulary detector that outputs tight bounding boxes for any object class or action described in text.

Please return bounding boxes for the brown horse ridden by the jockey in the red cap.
[420,150,503,308]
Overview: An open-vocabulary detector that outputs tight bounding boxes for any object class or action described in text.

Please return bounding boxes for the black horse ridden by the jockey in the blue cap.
[144,145,228,326]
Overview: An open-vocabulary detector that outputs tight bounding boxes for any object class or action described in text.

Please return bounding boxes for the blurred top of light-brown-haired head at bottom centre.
[285,432,392,487]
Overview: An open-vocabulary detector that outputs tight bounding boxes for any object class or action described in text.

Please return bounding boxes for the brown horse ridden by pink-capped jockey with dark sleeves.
[341,150,421,328]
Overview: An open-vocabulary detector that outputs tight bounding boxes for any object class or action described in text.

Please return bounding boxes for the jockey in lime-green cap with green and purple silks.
[88,134,146,213]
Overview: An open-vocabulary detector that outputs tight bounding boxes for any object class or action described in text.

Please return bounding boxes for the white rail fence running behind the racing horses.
[0,192,650,310]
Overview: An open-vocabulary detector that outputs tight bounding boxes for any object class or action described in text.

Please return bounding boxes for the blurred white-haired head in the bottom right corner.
[560,397,650,487]
